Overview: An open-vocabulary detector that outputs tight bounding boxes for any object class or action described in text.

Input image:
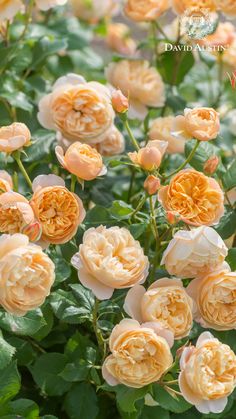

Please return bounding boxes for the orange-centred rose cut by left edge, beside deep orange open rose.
[0,191,35,234]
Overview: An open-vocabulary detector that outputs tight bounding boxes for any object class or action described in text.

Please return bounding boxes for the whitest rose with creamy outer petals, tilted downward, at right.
[161,227,228,278]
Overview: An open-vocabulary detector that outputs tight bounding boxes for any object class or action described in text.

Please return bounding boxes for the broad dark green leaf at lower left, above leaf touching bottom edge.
[30,353,70,396]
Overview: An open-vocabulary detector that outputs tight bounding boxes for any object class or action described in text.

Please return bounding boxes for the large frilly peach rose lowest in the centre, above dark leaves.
[102,319,173,388]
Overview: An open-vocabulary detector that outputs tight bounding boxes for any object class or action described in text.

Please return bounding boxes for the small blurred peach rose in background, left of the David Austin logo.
[106,23,137,55]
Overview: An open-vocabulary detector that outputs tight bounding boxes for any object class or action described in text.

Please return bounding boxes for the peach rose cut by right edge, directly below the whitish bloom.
[187,267,236,330]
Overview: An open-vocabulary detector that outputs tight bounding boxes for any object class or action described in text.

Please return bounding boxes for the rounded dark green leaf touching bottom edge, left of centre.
[64,383,98,419]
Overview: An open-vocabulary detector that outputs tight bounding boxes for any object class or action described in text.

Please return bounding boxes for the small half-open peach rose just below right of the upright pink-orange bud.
[128,140,168,171]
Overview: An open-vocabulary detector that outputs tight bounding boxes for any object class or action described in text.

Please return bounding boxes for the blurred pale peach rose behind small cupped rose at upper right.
[149,116,192,154]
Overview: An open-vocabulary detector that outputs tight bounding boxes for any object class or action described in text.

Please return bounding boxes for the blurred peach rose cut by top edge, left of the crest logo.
[124,0,170,22]
